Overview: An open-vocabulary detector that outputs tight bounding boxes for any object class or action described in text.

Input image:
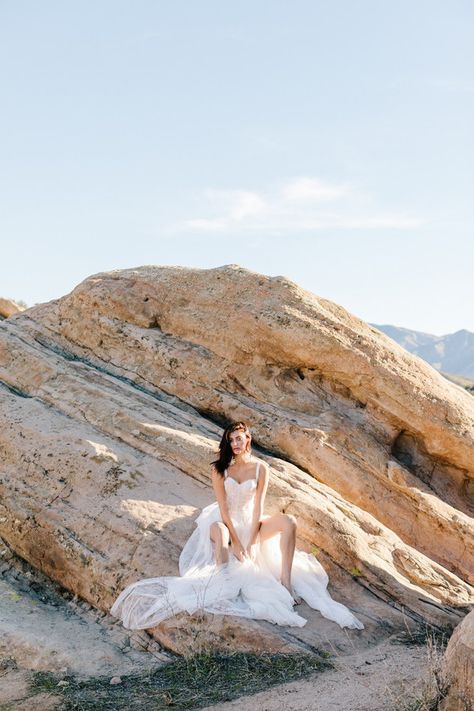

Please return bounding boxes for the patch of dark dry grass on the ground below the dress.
[30,652,332,711]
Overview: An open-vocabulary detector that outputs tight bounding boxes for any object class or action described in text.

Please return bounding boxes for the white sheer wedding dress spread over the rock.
[110,462,364,629]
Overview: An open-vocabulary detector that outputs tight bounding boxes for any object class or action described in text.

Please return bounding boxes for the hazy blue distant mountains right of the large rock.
[371,323,474,387]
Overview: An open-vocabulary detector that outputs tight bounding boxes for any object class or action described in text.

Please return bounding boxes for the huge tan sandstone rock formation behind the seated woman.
[0,265,474,649]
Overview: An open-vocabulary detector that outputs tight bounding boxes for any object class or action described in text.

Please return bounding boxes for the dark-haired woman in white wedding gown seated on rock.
[110,421,364,629]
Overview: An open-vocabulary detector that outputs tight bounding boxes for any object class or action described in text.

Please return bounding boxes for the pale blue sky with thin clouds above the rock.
[0,0,474,335]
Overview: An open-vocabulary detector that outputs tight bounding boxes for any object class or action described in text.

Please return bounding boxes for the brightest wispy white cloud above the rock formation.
[176,177,425,234]
